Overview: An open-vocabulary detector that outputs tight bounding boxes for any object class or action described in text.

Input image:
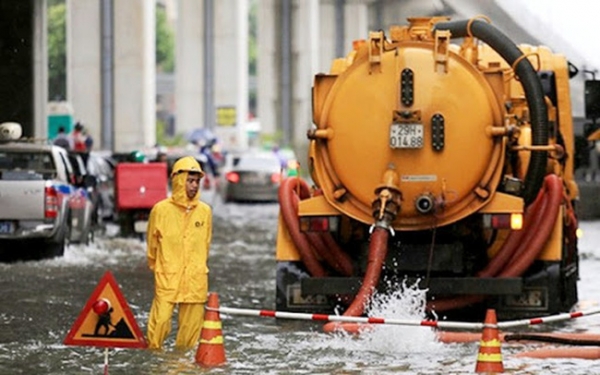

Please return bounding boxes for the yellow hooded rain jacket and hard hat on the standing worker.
[147,157,212,303]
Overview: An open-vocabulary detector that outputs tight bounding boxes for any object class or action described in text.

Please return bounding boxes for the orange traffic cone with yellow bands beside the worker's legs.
[196,293,225,367]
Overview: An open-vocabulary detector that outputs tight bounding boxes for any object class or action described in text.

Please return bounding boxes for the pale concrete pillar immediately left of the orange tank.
[258,0,327,153]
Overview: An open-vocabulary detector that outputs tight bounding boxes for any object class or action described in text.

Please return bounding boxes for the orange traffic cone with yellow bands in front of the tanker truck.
[475,309,504,374]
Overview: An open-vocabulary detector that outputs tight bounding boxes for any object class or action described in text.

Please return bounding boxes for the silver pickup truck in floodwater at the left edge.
[0,137,94,259]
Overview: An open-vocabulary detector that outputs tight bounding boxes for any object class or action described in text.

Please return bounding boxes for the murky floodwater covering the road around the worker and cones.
[0,195,600,375]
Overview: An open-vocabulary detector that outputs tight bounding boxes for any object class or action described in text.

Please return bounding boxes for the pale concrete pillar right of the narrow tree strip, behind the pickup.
[67,0,103,149]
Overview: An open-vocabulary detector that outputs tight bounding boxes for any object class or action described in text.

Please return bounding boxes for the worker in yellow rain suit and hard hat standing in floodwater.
[147,156,212,349]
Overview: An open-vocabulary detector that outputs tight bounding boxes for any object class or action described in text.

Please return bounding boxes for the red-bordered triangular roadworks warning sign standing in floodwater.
[64,271,148,348]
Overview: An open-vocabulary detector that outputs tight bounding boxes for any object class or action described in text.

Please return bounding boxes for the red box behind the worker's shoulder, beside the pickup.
[115,163,169,210]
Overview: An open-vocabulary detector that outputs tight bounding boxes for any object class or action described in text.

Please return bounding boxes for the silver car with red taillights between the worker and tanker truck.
[219,151,284,202]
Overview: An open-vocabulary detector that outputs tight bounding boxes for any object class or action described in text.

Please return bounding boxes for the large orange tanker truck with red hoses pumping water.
[276,13,578,319]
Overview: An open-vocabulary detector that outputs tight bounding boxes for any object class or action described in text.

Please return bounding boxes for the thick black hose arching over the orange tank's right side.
[434,19,548,205]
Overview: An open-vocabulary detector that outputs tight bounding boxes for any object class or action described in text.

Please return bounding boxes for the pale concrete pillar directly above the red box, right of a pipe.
[114,0,156,152]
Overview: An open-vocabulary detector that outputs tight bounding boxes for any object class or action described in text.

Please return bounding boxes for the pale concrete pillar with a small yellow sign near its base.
[175,0,248,148]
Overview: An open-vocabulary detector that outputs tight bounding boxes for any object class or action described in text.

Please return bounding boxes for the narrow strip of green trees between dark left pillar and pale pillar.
[48,0,67,100]
